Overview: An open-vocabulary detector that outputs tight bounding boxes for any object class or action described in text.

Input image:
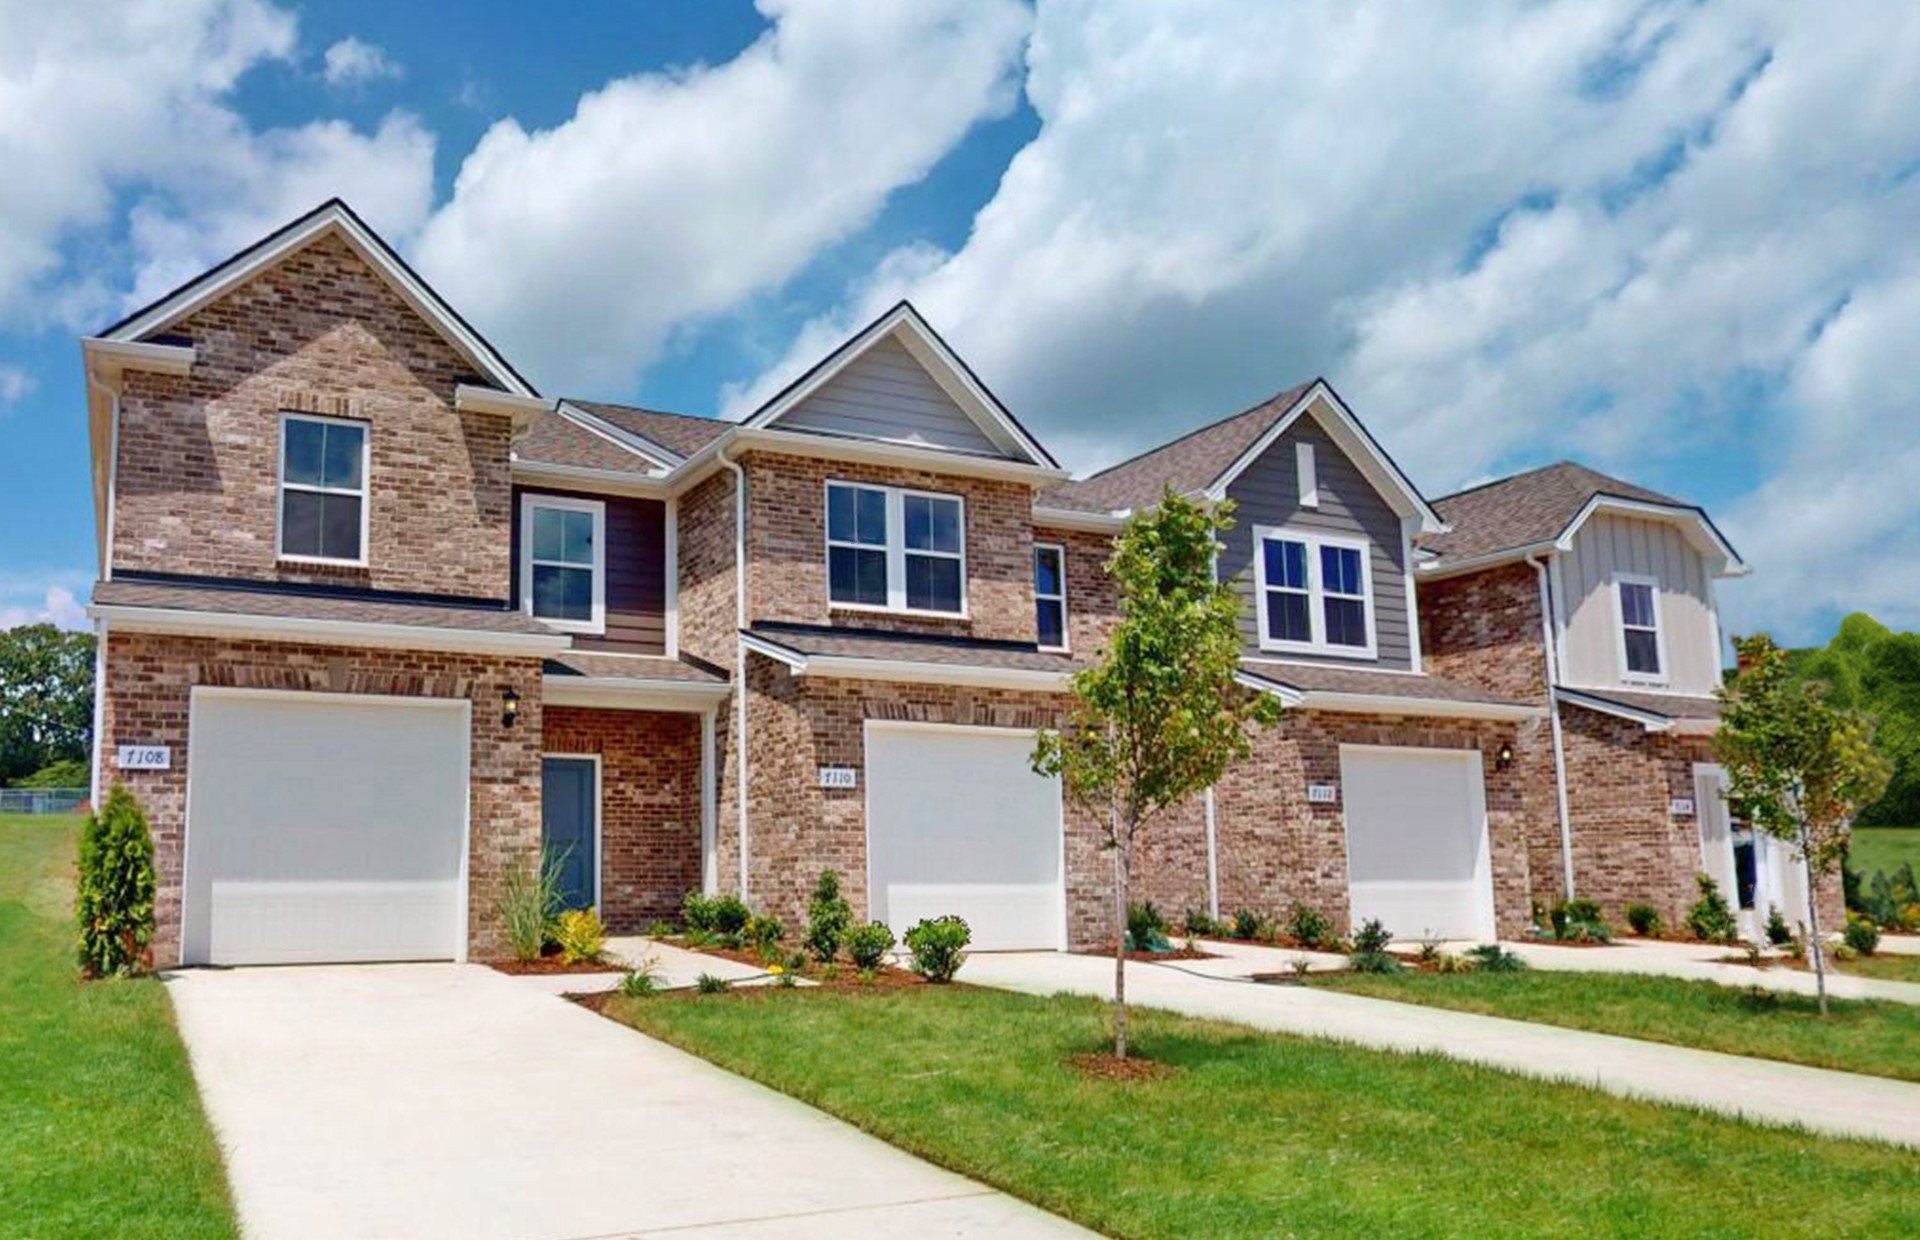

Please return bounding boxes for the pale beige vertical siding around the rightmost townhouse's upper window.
[1559,513,1720,693]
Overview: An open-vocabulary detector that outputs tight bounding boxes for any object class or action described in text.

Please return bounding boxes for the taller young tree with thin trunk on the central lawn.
[1033,489,1281,1060]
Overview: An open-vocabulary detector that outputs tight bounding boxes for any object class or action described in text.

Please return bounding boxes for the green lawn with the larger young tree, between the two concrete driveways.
[609,987,1920,1240]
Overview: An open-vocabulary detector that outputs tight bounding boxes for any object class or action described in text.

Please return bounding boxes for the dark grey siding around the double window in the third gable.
[1219,413,1413,672]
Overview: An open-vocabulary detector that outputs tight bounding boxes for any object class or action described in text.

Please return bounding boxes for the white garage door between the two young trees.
[1340,745,1494,941]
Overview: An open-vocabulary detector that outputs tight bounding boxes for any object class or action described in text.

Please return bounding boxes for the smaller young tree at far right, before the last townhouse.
[1713,633,1891,1015]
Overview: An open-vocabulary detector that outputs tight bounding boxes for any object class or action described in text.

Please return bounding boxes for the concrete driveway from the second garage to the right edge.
[962,948,1920,1146]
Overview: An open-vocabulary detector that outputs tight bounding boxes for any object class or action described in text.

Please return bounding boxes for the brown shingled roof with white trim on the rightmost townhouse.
[1421,461,1745,574]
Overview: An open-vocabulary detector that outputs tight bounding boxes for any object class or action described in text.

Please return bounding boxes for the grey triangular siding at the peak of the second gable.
[778,338,1004,457]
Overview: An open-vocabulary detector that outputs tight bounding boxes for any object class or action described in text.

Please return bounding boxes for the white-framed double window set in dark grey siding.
[1254,528,1375,658]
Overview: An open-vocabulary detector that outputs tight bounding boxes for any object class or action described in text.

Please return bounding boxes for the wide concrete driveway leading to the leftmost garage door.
[167,964,1087,1240]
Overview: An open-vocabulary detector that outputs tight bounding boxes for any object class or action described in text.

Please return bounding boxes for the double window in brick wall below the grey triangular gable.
[828,482,966,616]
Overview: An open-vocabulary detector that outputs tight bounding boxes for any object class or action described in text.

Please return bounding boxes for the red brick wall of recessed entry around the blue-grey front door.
[541,706,701,935]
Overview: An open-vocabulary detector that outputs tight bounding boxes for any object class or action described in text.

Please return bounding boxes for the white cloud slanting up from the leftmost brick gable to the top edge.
[417,0,1027,388]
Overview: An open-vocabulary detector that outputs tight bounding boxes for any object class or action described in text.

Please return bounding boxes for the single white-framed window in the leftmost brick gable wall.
[280,413,367,564]
